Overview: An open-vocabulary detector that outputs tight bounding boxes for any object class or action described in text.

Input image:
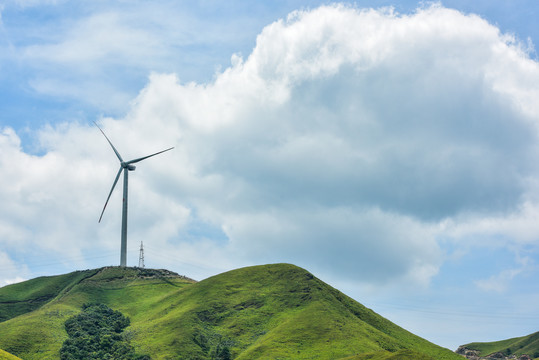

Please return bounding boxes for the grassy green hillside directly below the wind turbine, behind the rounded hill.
[0,267,193,360]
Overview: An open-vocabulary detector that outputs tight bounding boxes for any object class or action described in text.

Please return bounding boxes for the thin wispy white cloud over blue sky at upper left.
[0,0,274,116]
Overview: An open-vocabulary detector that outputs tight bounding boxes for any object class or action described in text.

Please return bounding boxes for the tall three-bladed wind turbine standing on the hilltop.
[94,121,174,267]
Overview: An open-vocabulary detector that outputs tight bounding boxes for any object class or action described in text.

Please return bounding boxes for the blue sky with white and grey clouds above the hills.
[0,0,539,350]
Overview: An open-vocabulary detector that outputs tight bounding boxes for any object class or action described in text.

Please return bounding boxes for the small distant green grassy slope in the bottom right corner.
[463,332,539,358]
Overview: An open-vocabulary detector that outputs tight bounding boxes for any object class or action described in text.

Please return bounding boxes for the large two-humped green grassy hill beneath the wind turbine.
[0,264,462,360]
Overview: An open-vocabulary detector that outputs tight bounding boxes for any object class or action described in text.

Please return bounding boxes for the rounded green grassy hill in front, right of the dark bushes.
[124,264,460,359]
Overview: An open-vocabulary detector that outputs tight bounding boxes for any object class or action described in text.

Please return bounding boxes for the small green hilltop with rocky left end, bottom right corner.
[457,332,539,360]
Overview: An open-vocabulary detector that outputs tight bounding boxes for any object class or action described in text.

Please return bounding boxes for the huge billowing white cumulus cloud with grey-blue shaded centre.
[2,5,539,290]
